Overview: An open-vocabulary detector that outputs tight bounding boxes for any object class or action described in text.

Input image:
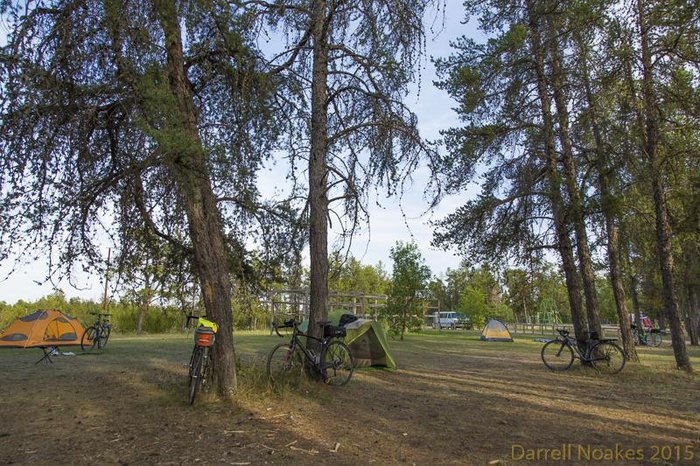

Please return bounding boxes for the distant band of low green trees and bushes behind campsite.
[0,242,662,346]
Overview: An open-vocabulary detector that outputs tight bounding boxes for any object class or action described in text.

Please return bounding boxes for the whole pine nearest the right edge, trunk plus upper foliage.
[625,0,700,372]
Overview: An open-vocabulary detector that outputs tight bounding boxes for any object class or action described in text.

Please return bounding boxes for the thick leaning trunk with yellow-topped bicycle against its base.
[155,0,237,396]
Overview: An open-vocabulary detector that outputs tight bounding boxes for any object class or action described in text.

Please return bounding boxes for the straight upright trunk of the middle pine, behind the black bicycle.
[308,0,328,356]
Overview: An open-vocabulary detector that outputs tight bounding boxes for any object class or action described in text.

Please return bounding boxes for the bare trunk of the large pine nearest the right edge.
[637,0,692,372]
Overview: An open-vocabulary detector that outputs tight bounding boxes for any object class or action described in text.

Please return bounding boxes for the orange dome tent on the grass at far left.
[0,311,85,348]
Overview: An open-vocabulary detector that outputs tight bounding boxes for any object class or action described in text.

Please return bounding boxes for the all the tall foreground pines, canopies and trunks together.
[0,0,700,395]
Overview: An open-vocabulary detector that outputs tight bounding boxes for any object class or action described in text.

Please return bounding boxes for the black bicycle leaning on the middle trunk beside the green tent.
[267,319,354,388]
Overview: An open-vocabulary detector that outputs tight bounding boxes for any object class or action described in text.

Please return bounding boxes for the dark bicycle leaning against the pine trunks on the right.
[541,329,626,374]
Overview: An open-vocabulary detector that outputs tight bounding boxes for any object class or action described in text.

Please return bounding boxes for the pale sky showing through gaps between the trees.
[0,0,479,304]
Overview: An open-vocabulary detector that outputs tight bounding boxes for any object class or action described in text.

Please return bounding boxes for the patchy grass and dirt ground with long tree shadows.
[0,331,700,465]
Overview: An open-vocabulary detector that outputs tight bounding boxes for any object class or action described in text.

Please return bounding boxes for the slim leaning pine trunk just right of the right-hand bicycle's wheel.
[576,33,639,362]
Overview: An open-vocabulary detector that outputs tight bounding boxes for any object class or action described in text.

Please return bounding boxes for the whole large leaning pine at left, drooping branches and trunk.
[0,0,302,395]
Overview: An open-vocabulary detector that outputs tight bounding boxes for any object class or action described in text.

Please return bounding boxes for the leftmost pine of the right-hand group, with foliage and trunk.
[435,0,596,341]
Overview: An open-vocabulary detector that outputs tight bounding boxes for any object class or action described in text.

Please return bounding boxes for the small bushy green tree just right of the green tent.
[384,241,431,340]
